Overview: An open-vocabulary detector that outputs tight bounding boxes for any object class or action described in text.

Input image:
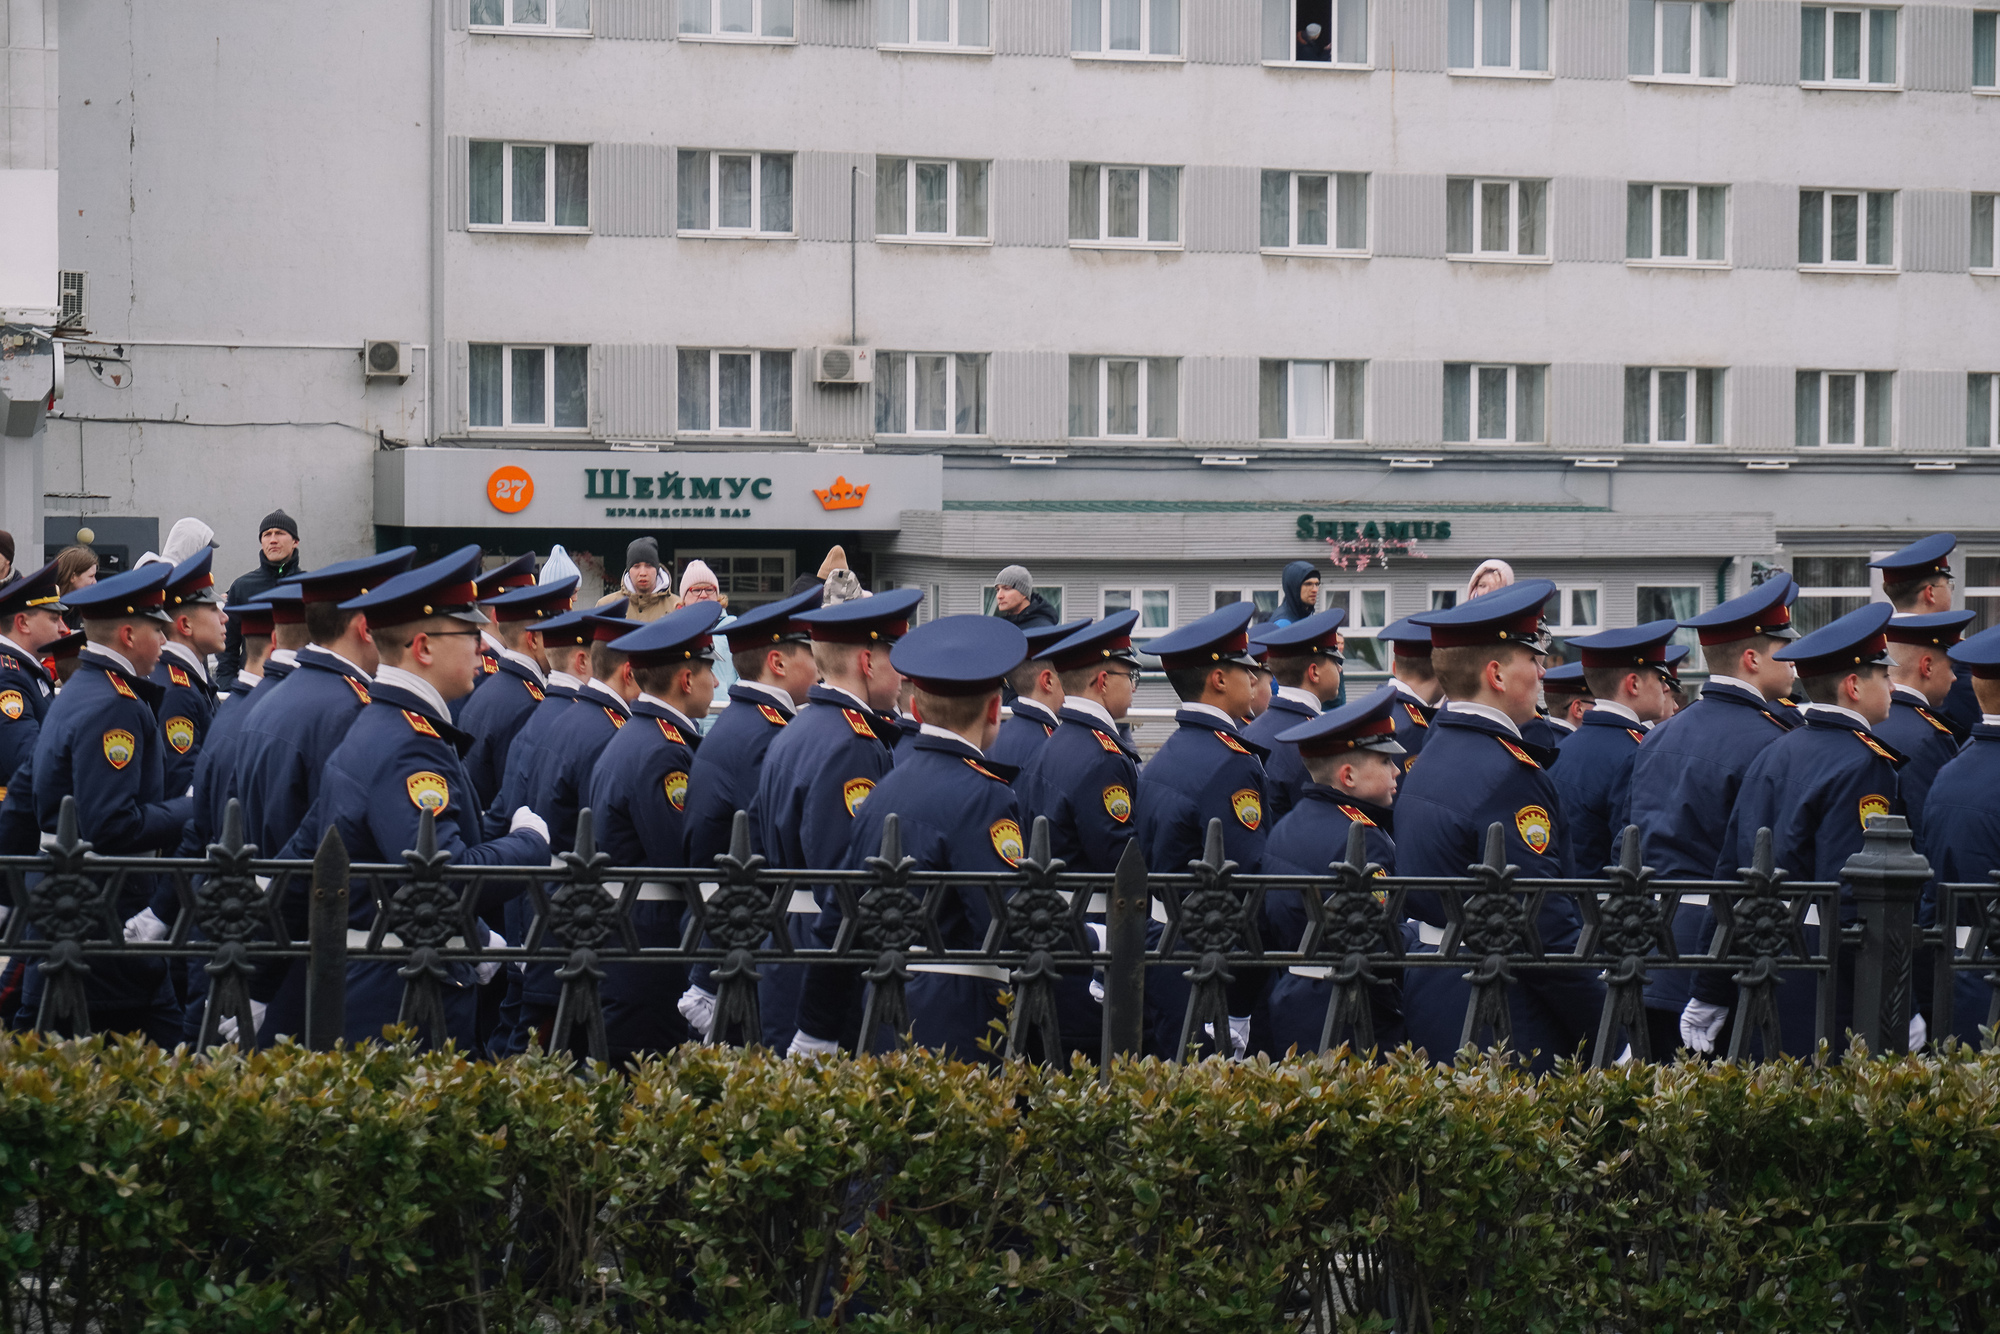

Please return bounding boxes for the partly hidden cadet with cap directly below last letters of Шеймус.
[678,588,820,1038]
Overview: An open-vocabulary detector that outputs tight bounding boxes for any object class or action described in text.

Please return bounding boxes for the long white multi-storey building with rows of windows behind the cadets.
[46,0,2000,680]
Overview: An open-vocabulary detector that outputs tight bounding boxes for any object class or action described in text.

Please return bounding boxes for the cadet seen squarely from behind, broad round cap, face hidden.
[790,604,1028,1060]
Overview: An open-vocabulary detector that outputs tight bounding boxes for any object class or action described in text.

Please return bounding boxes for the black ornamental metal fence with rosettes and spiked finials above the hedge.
[0,798,2000,1064]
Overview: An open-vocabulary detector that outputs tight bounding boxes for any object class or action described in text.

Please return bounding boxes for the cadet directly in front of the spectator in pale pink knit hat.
[586,602,722,1064]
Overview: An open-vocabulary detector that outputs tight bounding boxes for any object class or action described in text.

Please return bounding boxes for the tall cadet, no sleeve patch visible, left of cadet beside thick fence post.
[1628,576,1798,1058]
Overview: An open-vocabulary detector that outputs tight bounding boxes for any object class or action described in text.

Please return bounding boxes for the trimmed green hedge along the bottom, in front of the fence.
[0,1036,2000,1334]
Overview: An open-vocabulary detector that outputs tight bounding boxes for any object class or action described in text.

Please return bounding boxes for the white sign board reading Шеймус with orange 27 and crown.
[376,448,944,532]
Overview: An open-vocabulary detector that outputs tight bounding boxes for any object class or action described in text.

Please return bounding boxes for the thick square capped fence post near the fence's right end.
[1820,816,1930,1056]
